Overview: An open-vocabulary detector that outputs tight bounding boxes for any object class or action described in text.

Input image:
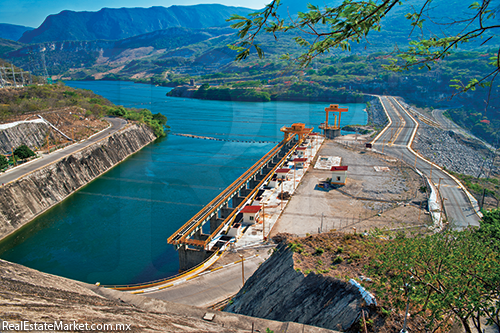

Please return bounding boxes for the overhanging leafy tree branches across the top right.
[229,0,500,91]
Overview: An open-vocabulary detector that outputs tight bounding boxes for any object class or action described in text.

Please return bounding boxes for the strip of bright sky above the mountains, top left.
[0,0,270,28]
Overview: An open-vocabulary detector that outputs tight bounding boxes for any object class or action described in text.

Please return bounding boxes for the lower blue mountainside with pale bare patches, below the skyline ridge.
[5,27,235,78]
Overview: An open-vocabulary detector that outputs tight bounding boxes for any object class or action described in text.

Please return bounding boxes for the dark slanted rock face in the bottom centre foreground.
[225,243,364,331]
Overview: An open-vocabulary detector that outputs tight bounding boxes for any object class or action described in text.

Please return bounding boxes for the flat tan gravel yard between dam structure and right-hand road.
[271,141,429,236]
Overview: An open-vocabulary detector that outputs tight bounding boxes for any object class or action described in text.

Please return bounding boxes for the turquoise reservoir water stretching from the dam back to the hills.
[0,81,367,284]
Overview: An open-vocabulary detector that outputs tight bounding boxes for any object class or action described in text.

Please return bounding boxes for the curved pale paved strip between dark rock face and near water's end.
[143,251,267,307]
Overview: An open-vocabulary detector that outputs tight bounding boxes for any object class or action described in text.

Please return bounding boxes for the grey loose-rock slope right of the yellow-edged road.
[413,122,499,177]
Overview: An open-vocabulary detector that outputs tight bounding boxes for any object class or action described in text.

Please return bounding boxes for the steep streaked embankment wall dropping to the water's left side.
[0,125,156,238]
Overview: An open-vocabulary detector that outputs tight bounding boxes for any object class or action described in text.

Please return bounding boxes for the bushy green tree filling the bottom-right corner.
[372,229,500,332]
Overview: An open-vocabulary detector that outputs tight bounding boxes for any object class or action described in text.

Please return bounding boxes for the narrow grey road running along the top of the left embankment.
[0,117,127,184]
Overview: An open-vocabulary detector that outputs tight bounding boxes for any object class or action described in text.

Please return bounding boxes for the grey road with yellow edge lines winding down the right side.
[375,96,479,229]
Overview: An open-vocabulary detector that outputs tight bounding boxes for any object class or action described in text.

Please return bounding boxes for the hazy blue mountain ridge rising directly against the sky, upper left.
[19,4,254,43]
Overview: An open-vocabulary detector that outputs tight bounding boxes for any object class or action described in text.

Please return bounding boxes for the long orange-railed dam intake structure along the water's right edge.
[167,123,313,271]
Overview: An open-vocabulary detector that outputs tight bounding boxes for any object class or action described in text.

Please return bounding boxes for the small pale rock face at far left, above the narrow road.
[0,123,49,154]
